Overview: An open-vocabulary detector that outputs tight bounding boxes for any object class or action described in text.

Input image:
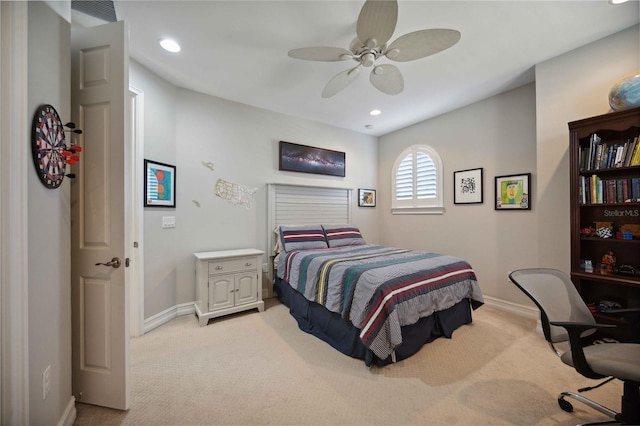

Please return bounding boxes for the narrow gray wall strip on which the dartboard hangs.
[27,2,71,425]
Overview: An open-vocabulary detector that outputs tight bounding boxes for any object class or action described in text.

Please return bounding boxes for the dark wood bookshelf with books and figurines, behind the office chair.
[569,107,640,340]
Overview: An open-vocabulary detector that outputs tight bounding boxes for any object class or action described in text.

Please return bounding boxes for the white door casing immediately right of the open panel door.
[128,86,144,337]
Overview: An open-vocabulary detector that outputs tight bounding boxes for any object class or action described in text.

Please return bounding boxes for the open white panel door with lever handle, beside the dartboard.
[71,22,132,410]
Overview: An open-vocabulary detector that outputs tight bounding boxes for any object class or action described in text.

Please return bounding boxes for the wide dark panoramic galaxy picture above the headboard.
[279,141,346,177]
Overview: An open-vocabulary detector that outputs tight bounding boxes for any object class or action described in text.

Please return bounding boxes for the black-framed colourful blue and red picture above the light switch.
[144,159,176,207]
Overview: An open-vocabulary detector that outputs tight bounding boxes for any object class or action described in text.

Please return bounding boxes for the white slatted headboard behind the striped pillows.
[267,183,352,272]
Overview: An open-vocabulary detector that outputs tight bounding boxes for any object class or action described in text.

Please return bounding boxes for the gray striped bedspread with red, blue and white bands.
[277,245,484,359]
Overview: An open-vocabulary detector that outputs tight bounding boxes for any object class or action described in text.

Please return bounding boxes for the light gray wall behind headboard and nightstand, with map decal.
[130,61,378,319]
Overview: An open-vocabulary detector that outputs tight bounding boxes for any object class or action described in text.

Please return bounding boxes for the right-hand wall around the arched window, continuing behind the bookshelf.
[379,26,640,305]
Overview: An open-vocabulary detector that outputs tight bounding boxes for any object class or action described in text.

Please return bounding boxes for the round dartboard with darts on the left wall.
[31,105,67,189]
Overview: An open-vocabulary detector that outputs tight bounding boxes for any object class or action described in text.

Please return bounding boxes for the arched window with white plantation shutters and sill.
[391,145,444,214]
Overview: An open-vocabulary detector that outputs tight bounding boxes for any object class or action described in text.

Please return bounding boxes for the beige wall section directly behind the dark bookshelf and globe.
[536,25,640,272]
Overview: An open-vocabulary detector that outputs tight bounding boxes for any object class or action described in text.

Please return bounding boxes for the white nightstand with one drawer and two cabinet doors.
[193,249,264,326]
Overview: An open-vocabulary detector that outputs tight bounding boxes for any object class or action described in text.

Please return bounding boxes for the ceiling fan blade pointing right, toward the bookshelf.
[385,29,460,62]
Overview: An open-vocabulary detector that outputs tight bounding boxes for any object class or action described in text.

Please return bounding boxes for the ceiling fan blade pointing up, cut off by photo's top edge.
[356,0,398,48]
